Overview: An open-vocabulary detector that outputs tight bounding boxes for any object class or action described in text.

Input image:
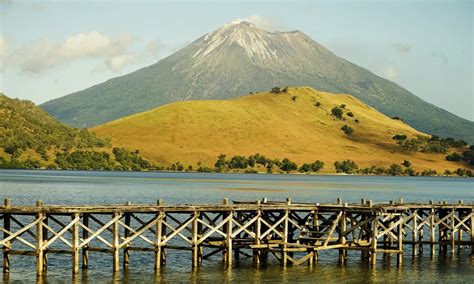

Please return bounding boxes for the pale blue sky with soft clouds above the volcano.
[0,0,474,121]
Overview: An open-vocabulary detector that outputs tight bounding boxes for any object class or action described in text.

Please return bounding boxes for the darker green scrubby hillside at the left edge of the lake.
[0,94,153,170]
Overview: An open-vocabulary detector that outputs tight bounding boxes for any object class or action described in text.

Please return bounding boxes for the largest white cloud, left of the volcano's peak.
[7,31,133,73]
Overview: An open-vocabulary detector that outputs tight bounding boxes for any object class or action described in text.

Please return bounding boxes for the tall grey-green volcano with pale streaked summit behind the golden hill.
[42,21,474,142]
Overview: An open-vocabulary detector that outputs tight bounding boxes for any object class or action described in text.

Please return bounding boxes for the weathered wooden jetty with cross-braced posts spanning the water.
[0,199,474,275]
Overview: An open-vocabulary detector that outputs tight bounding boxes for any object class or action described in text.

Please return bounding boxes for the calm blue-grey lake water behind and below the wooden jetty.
[0,170,474,283]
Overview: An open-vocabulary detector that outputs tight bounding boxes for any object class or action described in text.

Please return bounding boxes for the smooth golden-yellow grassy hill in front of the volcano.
[91,87,470,173]
